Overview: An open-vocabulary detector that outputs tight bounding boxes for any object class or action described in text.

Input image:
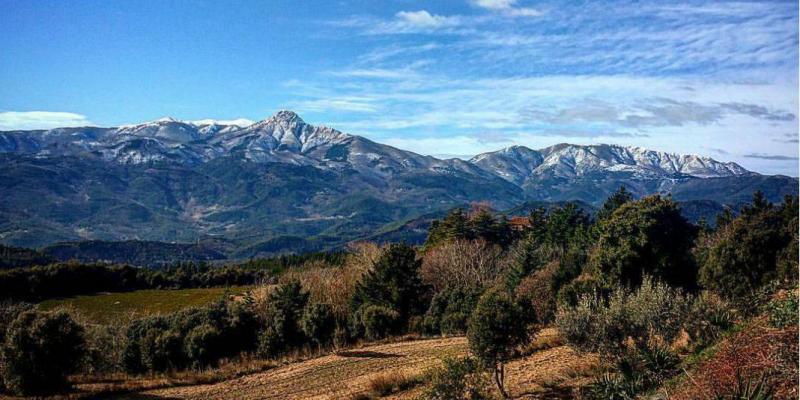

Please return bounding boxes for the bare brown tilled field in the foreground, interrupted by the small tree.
[127,331,597,400]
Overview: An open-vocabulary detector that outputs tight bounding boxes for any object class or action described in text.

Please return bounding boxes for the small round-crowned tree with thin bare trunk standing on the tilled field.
[467,289,528,397]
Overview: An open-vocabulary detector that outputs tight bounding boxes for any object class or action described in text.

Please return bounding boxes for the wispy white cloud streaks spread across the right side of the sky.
[314,0,798,174]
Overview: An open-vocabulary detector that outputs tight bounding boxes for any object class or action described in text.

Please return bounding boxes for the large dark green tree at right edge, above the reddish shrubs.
[696,193,798,299]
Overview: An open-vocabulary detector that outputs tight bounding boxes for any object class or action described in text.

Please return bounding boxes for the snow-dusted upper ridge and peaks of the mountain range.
[0,110,751,180]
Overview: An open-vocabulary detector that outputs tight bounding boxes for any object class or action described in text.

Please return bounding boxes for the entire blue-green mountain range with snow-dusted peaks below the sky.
[0,111,798,257]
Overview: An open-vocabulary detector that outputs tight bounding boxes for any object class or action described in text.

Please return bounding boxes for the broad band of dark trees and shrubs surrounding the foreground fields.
[0,188,798,399]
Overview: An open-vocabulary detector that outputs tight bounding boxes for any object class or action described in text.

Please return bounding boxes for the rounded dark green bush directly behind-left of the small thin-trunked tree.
[423,287,482,335]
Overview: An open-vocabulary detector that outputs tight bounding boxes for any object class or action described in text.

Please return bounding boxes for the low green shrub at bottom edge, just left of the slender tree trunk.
[421,358,492,400]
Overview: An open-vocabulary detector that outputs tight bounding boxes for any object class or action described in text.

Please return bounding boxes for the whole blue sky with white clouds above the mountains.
[0,0,798,176]
